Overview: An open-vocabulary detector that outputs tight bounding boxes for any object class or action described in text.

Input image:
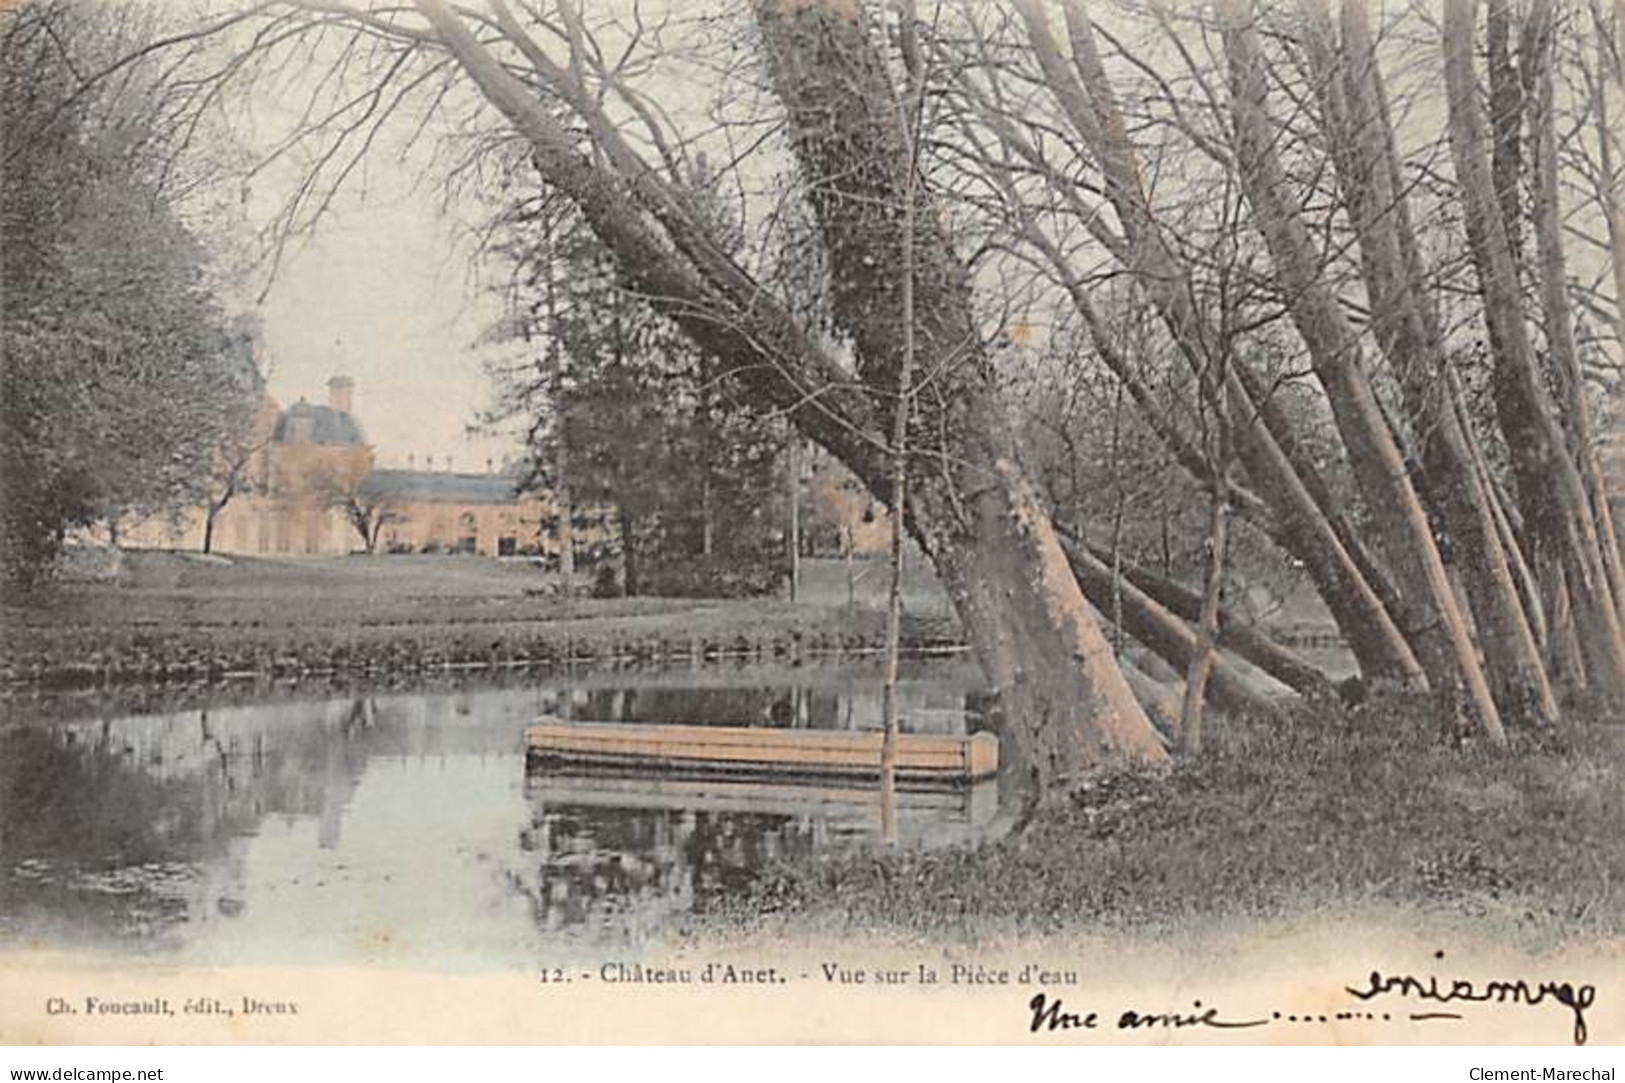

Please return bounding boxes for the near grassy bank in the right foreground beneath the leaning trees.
[696,706,1625,946]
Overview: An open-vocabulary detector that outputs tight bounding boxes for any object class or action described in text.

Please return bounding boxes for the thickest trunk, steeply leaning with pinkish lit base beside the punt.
[756,0,1165,790]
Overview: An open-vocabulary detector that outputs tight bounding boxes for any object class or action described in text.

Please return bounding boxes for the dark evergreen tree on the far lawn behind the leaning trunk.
[481,170,787,594]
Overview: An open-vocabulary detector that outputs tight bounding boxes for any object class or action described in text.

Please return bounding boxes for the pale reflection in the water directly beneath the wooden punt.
[530,771,999,828]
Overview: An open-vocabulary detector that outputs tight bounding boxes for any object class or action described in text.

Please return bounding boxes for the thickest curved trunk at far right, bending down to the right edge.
[1443,0,1625,702]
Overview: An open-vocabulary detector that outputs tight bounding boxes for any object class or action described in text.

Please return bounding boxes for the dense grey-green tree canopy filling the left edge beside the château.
[0,0,260,585]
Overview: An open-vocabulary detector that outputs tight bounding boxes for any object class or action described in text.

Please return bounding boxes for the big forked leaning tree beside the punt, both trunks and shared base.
[416,0,1167,785]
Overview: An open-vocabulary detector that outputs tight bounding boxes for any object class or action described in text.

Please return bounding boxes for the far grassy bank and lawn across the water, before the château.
[0,553,944,686]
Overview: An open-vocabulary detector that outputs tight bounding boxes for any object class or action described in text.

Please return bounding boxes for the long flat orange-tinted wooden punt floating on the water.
[525,717,999,789]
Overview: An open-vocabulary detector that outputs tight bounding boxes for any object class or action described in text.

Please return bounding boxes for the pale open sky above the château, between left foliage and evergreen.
[198,8,522,472]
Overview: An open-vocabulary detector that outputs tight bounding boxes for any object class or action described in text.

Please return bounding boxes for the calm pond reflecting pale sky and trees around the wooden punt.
[0,659,1014,969]
